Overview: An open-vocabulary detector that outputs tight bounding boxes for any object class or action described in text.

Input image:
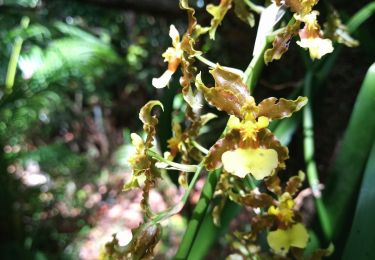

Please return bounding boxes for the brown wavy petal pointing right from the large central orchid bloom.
[258,97,307,120]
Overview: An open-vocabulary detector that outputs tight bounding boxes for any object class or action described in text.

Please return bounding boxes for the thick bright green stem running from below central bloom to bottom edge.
[175,169,221,259]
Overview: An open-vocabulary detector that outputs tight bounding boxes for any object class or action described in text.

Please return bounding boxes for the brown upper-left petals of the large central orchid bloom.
[197,65,251,118]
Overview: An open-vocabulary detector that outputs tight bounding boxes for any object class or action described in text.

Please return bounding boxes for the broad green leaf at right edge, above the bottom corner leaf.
[323,64,375,242]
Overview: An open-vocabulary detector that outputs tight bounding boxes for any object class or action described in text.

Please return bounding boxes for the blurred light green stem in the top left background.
[5,17,30,95]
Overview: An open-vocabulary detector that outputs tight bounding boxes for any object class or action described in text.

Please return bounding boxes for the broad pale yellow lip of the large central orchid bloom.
[221,148,278,180]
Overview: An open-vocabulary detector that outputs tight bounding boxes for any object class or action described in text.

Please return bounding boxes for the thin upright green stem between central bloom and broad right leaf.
[303,70,332,240]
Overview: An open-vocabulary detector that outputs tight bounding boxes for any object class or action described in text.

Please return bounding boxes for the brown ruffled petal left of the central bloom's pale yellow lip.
[205,130,241,171]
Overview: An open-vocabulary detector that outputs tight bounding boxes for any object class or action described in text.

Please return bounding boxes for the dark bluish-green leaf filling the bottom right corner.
[343,142,375,260]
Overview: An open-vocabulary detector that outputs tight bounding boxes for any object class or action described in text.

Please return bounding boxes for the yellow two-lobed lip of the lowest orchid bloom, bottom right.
[267,223,309,255]
